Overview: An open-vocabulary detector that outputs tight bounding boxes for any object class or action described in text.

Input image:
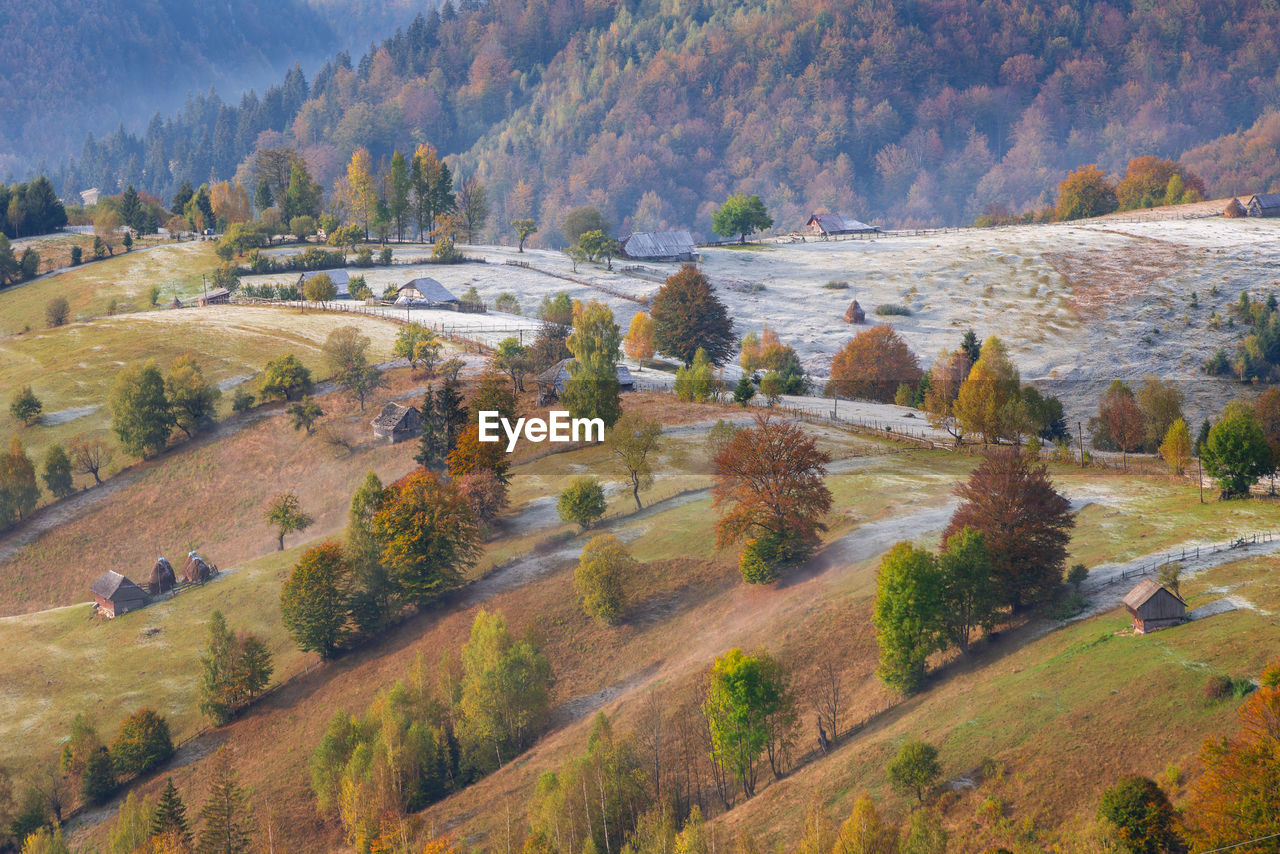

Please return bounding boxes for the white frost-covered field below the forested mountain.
[247,218,1280,420]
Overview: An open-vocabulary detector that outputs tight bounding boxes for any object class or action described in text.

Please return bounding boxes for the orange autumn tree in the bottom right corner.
[1183,662,1280,851]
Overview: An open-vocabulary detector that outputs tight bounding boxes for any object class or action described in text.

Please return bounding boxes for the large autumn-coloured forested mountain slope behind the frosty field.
[45,0,1280,234]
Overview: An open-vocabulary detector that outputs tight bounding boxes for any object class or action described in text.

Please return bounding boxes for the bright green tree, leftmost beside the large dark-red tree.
[872,543,943,694]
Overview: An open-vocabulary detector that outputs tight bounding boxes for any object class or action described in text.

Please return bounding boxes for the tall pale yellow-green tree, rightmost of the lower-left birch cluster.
[458,608,552,769]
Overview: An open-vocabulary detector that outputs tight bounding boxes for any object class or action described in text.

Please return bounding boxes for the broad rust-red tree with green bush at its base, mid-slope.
[712,414,832,584]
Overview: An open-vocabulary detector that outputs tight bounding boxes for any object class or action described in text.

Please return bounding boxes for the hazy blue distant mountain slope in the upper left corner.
[0,0,343,175]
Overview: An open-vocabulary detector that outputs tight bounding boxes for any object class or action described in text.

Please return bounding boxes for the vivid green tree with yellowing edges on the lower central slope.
[703,648,787,798]
